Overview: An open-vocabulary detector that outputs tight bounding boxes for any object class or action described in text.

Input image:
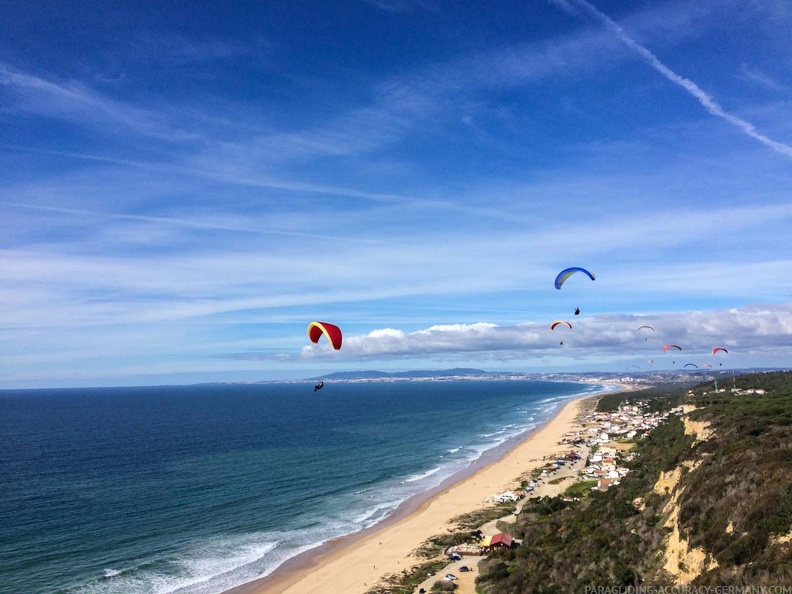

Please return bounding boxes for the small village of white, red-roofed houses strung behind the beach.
[415,402,683,594]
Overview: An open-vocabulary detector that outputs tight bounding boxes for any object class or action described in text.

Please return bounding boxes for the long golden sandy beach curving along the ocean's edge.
[232,388,597,594]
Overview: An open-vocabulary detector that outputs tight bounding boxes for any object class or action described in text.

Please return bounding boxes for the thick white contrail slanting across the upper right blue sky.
[554,0,792,157]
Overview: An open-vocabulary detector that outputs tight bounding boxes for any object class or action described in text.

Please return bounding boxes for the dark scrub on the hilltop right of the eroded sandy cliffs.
[679,372,792,585]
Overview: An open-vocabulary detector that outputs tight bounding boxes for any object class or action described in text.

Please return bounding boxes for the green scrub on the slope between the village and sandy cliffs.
[478,412,691,594]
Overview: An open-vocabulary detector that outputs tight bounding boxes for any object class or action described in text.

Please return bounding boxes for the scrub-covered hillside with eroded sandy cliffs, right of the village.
[477,372,792,594]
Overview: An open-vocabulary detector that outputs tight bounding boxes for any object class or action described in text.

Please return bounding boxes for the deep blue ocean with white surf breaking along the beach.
[0,380,603,594]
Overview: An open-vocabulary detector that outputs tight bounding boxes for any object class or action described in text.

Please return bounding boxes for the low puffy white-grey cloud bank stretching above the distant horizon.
[301,304,792,362]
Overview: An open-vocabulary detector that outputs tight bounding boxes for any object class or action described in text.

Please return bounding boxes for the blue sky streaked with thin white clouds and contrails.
[0,0,792,388]
